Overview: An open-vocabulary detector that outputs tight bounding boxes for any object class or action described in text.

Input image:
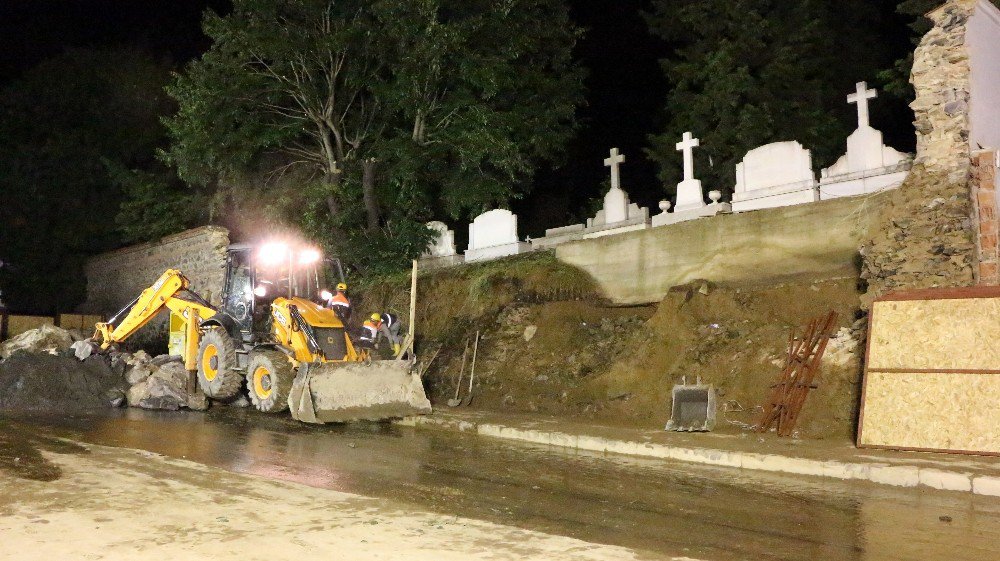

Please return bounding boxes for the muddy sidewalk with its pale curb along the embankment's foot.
[398,409,1000,496]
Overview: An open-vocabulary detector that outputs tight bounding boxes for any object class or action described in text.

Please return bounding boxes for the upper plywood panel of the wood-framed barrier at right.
[867,298,1000,370]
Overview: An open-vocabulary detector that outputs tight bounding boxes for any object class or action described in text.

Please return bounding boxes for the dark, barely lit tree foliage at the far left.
[0,49,171,312]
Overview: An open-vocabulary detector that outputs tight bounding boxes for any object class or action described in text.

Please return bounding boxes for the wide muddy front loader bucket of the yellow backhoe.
[288,360,431,423]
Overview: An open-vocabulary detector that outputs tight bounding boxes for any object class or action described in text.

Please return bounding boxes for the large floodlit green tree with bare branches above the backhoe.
[164,0,582,272]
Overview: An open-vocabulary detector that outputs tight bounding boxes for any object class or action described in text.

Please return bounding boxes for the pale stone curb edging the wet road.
[396,417,1000,497]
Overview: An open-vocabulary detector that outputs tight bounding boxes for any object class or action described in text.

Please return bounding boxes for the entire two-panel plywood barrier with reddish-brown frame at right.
[858,289,1000,455]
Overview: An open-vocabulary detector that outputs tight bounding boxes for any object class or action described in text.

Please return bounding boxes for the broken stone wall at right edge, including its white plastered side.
[862,0,1000,305]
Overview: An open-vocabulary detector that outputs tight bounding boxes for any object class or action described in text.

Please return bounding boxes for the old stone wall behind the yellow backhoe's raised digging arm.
[80,226,229,341]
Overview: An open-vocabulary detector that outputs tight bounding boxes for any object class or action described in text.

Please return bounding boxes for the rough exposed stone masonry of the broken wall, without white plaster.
[861,0,978,307]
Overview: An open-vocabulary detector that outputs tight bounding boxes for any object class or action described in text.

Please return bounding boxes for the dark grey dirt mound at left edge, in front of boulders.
[0,351,128,413]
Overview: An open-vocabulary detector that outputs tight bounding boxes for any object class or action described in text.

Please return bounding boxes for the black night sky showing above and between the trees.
[0,0,912,241]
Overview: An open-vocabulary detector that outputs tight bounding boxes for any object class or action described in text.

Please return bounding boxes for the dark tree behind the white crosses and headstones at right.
[647,0,891,199]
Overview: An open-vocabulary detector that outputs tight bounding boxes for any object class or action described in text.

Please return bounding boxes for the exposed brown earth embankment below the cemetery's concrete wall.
[360,255,863,438]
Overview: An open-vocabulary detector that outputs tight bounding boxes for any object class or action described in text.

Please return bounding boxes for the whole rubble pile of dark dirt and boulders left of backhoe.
[0,326,208,413]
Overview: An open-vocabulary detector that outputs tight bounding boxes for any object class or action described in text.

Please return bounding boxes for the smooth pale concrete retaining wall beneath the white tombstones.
[556,193,886,305]
